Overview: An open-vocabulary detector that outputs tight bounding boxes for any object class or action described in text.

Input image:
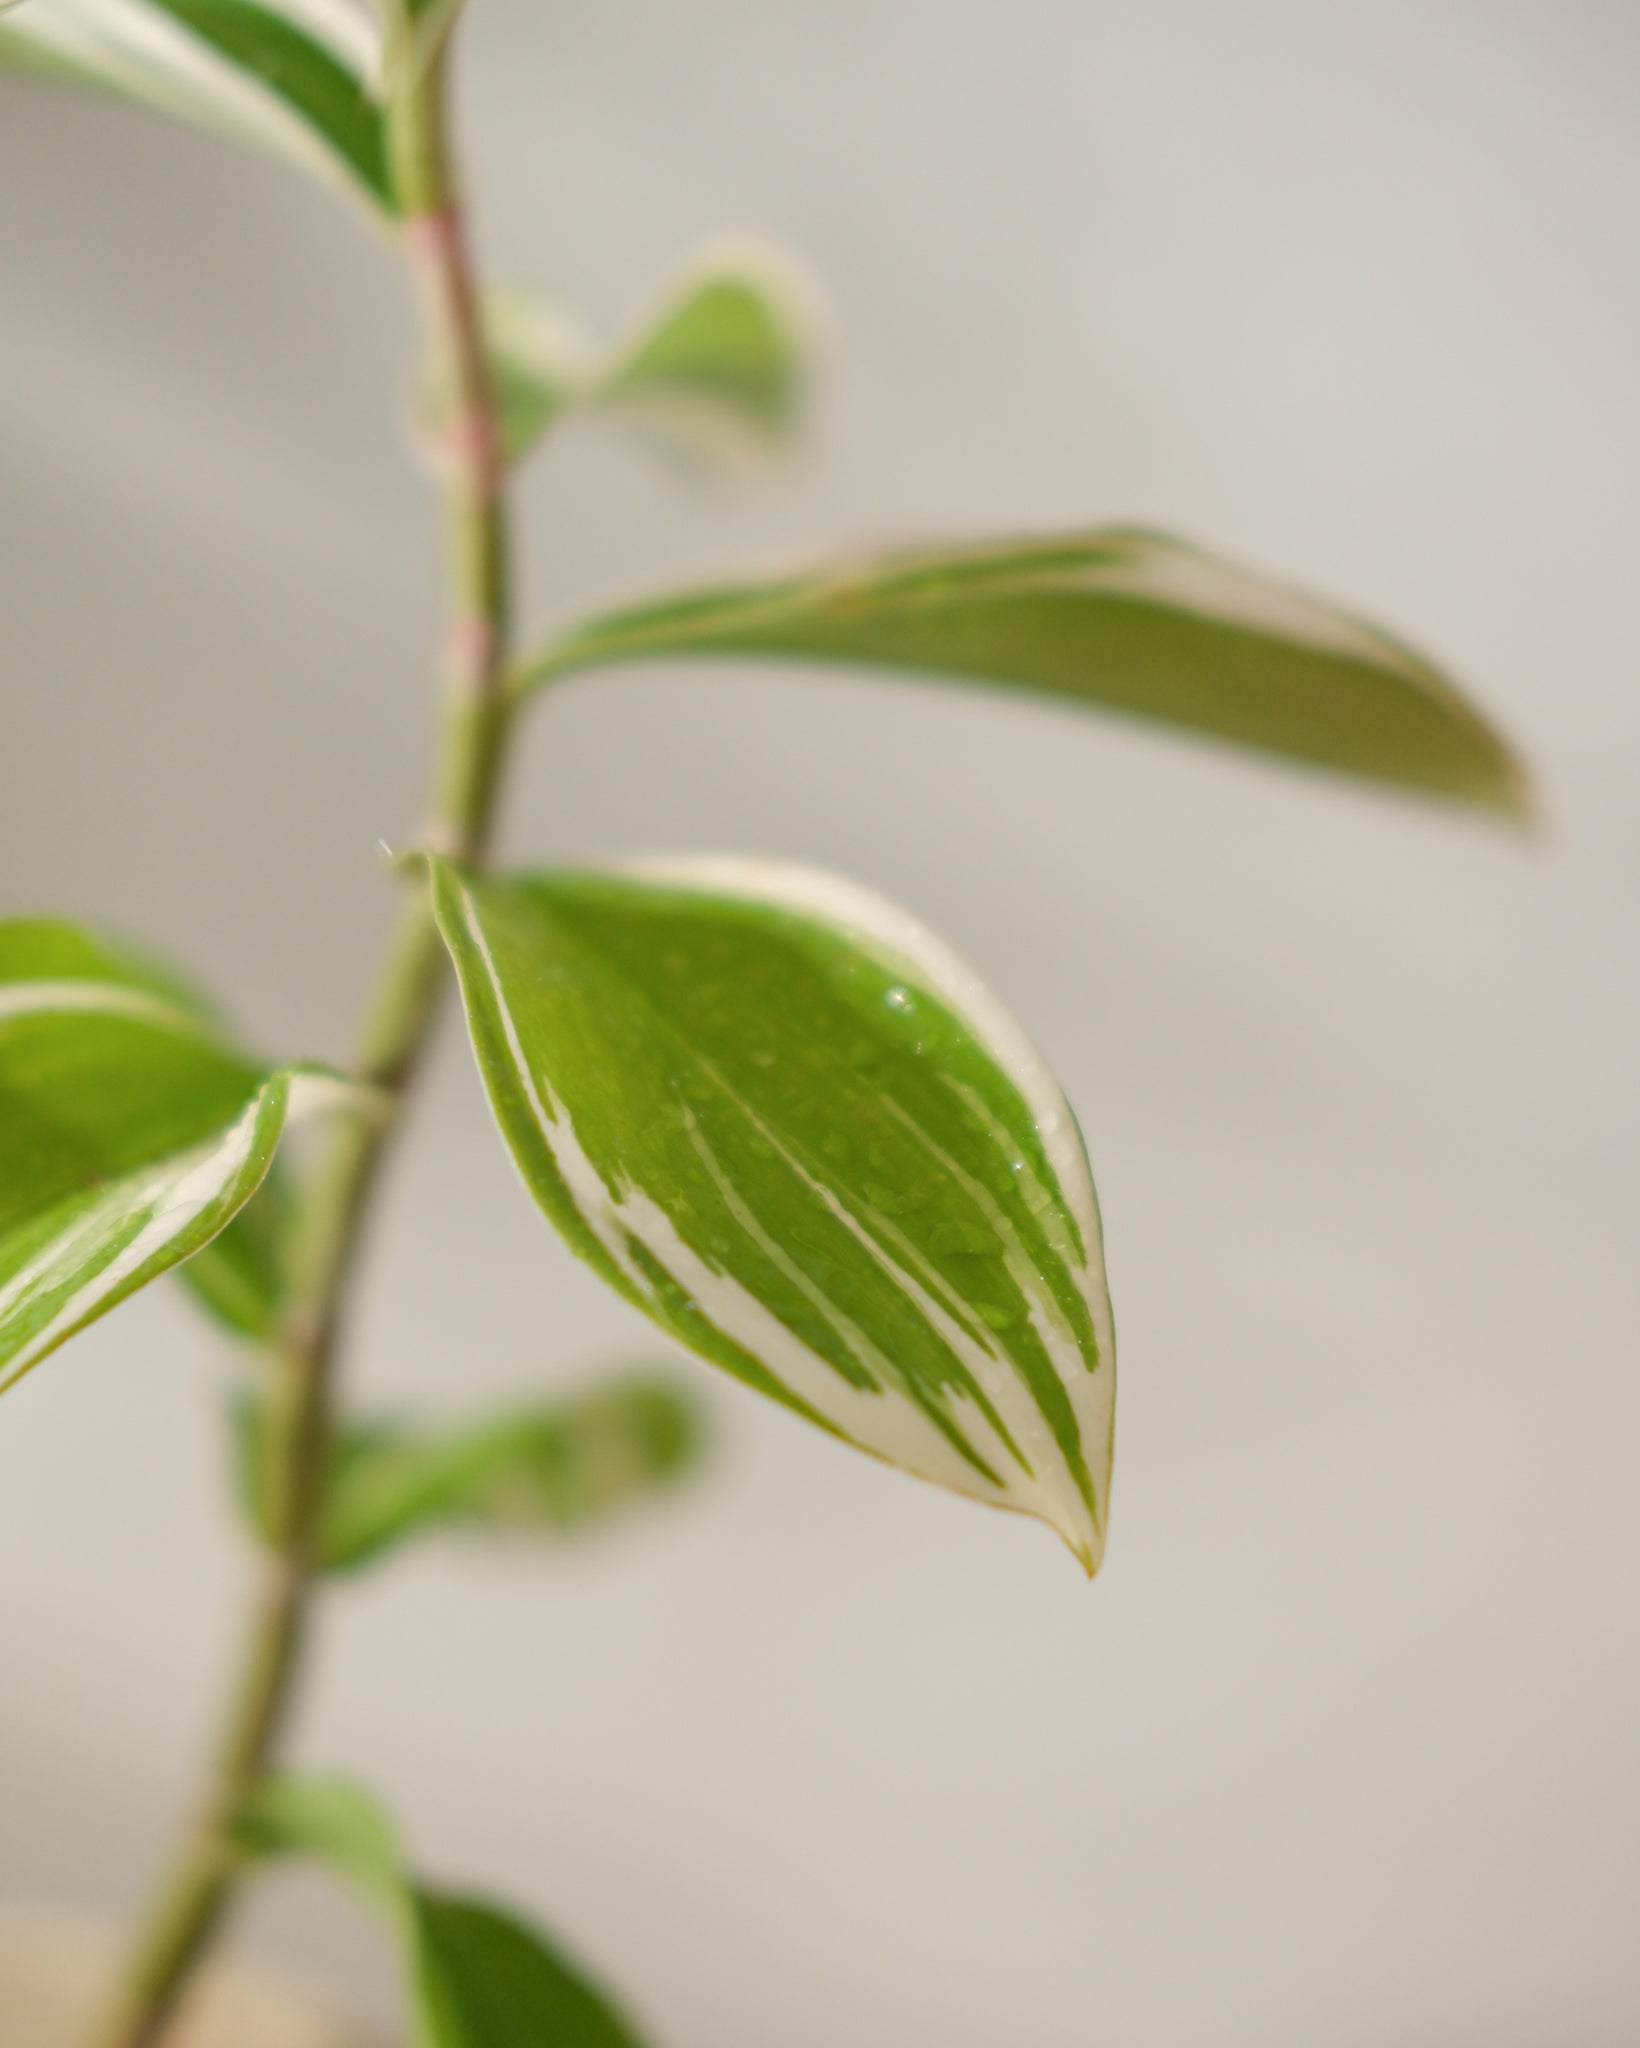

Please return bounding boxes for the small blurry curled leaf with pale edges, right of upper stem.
[485,242,819,477]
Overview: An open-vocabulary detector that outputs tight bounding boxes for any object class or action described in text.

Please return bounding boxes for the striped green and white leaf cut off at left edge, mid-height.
[0,920,338,1389]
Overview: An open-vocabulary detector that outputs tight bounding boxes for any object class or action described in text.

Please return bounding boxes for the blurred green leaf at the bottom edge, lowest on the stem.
[235,1778,639,2048]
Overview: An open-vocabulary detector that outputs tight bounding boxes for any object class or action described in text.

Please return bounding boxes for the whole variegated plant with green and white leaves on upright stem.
[0,0,1527,2048]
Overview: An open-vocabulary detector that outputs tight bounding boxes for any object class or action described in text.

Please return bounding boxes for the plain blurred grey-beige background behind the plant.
[0,0,1640,2048]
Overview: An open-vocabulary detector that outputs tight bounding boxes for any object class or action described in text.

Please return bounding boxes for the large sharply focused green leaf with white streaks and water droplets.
[430,860,1116,1571]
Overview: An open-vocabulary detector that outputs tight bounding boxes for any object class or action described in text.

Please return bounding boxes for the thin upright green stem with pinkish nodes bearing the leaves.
[76,32,508,2048]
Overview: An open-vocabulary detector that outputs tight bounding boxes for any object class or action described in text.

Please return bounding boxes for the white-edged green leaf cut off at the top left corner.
[0,0,393,213]
